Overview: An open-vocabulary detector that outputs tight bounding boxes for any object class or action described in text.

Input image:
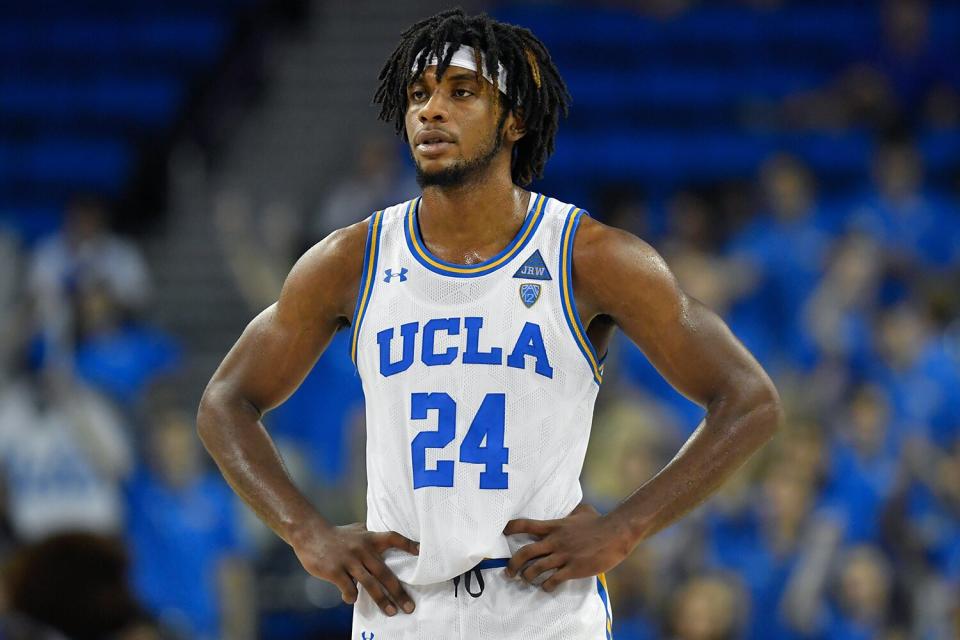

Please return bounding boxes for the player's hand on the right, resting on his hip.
[503,503,632,592]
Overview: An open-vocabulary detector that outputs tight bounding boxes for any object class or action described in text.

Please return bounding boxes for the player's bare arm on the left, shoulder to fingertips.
[197,222,417,615]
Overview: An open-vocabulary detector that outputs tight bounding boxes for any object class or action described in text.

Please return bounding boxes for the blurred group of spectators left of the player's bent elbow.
[0,194,255,640]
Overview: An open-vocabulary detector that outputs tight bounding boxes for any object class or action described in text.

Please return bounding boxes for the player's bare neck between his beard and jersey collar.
[417,172,530,264]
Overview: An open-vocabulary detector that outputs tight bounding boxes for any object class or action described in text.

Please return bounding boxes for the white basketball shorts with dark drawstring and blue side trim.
[351,559,612,640]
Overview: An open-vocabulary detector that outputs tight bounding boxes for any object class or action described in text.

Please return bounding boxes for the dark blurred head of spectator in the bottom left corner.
[0,533,160,640]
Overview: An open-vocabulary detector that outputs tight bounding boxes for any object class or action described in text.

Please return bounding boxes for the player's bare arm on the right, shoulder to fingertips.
[504,217,782,591]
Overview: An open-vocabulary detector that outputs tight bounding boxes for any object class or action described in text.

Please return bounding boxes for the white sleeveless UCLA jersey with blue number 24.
[351,193,603,585]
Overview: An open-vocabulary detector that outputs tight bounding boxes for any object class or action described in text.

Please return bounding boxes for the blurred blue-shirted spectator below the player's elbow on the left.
[127,407,256,640]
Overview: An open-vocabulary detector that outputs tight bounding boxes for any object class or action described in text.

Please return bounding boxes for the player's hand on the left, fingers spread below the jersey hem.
[293,523,420,616]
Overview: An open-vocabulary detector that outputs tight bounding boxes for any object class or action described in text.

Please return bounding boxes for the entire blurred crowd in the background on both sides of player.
[0,1,960,640]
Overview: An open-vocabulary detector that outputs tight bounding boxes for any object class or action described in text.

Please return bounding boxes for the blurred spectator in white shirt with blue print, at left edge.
[0,364,133,540]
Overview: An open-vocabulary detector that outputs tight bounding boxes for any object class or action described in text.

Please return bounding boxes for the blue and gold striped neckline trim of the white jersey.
[403,193,547,278]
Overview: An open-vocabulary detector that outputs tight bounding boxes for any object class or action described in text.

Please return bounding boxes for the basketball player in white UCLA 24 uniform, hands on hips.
[198,10,781,640]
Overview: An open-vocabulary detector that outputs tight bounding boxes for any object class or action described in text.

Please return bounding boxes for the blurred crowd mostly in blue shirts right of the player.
[585,132,960,640]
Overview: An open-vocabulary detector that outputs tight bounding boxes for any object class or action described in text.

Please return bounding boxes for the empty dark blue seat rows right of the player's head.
[495,2,960,188]
